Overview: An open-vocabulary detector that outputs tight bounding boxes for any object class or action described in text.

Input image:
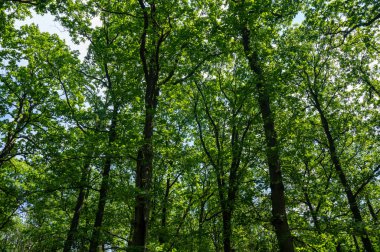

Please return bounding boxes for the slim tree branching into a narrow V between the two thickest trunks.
[194,58,254,251]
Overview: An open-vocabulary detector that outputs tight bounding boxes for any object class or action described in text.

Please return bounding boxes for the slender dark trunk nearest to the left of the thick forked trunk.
[89,105,118,252]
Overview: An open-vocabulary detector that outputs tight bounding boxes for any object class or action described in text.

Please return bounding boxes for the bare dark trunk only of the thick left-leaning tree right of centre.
[242,27,294,252]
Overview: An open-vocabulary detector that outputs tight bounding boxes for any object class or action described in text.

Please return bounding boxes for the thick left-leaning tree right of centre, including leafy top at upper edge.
[224,1,295,251]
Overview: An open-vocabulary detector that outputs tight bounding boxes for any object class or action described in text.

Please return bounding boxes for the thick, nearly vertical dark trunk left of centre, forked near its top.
[128,0,167,251]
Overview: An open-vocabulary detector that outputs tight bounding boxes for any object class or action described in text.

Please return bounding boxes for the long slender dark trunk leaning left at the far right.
[309,89,374,252]
